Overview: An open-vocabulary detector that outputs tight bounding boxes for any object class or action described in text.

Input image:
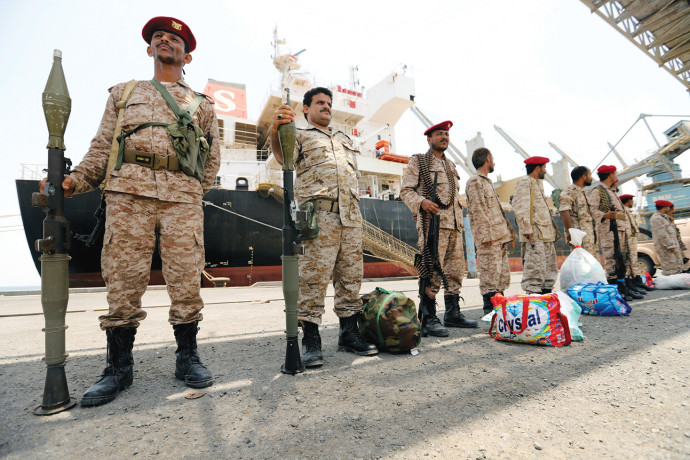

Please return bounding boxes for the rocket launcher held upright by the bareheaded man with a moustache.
[278,88,306,375]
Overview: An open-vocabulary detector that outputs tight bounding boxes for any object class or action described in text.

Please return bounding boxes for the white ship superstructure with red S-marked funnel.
[206,28,415,200]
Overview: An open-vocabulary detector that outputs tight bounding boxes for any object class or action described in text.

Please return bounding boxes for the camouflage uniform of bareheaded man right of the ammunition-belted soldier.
[465,173,517,295]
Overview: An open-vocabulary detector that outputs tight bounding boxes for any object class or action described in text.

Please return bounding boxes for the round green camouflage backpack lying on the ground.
[359,287,422,353]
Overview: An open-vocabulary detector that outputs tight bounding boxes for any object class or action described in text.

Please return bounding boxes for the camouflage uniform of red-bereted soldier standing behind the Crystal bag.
[512,175,561,294]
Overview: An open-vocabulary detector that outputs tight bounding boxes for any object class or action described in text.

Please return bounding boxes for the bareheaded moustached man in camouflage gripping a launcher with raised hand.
[271,87,378,367]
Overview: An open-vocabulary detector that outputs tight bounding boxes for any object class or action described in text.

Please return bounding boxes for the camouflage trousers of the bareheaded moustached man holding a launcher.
[297,211,363,324]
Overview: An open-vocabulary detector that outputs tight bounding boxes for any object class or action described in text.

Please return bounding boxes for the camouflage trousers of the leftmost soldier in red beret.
[98,192,204,329]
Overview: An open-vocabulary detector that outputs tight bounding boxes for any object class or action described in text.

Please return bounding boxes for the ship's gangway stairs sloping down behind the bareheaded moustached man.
[257,183,417,275]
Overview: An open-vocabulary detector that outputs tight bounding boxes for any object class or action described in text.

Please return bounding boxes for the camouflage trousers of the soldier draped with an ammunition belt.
[417,228,465,295]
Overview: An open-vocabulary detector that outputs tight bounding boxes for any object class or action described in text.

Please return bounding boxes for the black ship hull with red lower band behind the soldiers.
[16,180,568,287]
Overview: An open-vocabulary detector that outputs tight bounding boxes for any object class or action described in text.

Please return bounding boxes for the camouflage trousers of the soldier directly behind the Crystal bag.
[521,241,558,294]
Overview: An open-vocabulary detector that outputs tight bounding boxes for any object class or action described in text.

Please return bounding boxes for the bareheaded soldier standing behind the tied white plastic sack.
[559,166,599,260]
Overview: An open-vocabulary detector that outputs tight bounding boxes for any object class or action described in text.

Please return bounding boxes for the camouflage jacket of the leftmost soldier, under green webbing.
[71,80,220,204]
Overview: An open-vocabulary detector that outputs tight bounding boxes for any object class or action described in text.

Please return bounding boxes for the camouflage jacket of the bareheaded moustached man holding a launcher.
[295,124,362,227]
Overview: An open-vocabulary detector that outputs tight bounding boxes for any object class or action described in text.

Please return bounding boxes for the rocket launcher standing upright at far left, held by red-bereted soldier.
[31,50,77,415]
